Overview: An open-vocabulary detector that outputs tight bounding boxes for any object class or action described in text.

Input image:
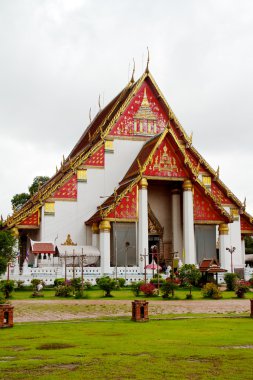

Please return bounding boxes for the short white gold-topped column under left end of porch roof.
[99,220,111,275]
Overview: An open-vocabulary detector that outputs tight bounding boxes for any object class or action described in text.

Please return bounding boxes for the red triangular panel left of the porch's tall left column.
[107,185,138,219]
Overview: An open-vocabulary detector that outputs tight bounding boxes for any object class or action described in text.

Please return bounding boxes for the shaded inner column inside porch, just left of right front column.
[171,189,183,259]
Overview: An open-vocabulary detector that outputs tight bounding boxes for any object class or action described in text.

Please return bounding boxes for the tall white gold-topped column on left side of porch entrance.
[138,178,148,273]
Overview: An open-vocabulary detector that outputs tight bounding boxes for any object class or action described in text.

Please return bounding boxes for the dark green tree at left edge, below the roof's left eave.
[0,230,17,275]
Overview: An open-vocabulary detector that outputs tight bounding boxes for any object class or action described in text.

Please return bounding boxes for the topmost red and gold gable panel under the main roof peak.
[110,82,168,136]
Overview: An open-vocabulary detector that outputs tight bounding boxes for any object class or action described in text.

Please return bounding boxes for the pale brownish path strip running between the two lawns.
[11,299,250,322]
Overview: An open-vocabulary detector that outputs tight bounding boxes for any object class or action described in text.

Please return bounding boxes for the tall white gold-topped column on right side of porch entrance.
[183,180,197,264]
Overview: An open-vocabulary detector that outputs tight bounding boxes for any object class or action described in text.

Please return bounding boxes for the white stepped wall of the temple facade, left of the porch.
[41,140,144,245]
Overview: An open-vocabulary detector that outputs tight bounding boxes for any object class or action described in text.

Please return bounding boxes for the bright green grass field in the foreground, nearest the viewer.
[0,317,253,380]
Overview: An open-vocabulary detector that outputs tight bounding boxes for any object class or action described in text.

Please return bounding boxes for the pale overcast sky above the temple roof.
[0,0,253,217]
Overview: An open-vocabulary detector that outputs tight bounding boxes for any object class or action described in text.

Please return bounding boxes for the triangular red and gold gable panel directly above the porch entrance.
[144,139,188,178]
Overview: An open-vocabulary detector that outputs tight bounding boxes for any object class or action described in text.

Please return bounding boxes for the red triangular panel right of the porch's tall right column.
[193,187,224,222]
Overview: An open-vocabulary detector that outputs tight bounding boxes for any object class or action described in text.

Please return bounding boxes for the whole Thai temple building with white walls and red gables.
[4,67,253,281]
